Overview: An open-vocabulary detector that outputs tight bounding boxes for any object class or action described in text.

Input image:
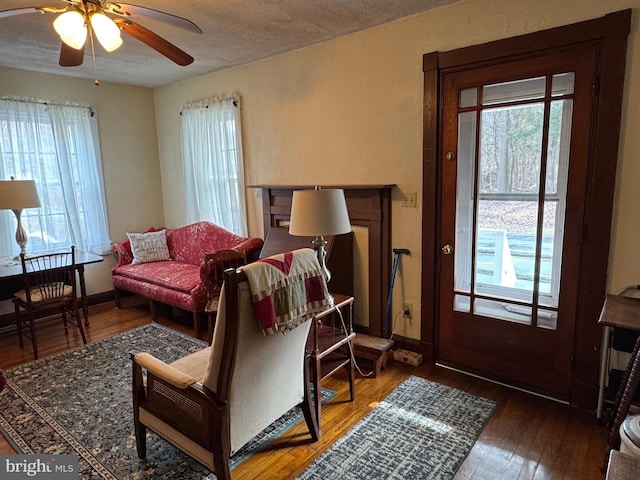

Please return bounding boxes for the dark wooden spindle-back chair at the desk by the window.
[13,246,87,358]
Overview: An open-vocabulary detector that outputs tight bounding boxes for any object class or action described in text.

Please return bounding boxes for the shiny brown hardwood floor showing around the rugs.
[0,299,606,480]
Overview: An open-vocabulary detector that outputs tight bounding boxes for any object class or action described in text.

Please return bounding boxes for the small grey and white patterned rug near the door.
[297,377,496,480]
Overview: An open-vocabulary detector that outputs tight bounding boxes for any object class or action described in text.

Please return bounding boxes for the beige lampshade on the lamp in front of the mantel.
[289,188,351,236]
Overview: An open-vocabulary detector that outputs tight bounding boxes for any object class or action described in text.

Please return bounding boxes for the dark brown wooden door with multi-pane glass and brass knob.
[438,48,596,399]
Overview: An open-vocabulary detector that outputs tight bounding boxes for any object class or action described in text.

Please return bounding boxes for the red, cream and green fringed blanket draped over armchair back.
[242,248,330,335]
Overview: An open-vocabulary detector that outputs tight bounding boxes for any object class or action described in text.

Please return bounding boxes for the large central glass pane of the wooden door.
[476,103,544,301]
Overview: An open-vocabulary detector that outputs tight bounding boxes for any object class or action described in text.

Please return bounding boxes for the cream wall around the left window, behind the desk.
[0,67,164,294]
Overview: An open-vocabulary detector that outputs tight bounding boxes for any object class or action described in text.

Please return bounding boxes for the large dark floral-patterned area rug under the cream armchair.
[0,323,335,480]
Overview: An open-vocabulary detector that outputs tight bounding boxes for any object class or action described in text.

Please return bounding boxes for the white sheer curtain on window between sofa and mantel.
[181,94,247,237]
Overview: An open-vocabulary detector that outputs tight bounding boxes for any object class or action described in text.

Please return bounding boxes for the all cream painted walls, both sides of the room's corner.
[0,0,640,338]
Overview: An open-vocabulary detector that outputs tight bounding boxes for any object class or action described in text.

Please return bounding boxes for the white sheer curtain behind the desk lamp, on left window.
[0,95,111,256]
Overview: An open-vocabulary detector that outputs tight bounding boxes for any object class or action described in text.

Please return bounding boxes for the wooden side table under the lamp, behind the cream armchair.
[307,294,356,434]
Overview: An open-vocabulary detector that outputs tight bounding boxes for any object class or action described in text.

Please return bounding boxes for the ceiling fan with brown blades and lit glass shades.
[0,0,202,71]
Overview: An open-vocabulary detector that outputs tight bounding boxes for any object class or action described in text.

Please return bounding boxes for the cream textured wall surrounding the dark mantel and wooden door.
[155,0,640,338]
